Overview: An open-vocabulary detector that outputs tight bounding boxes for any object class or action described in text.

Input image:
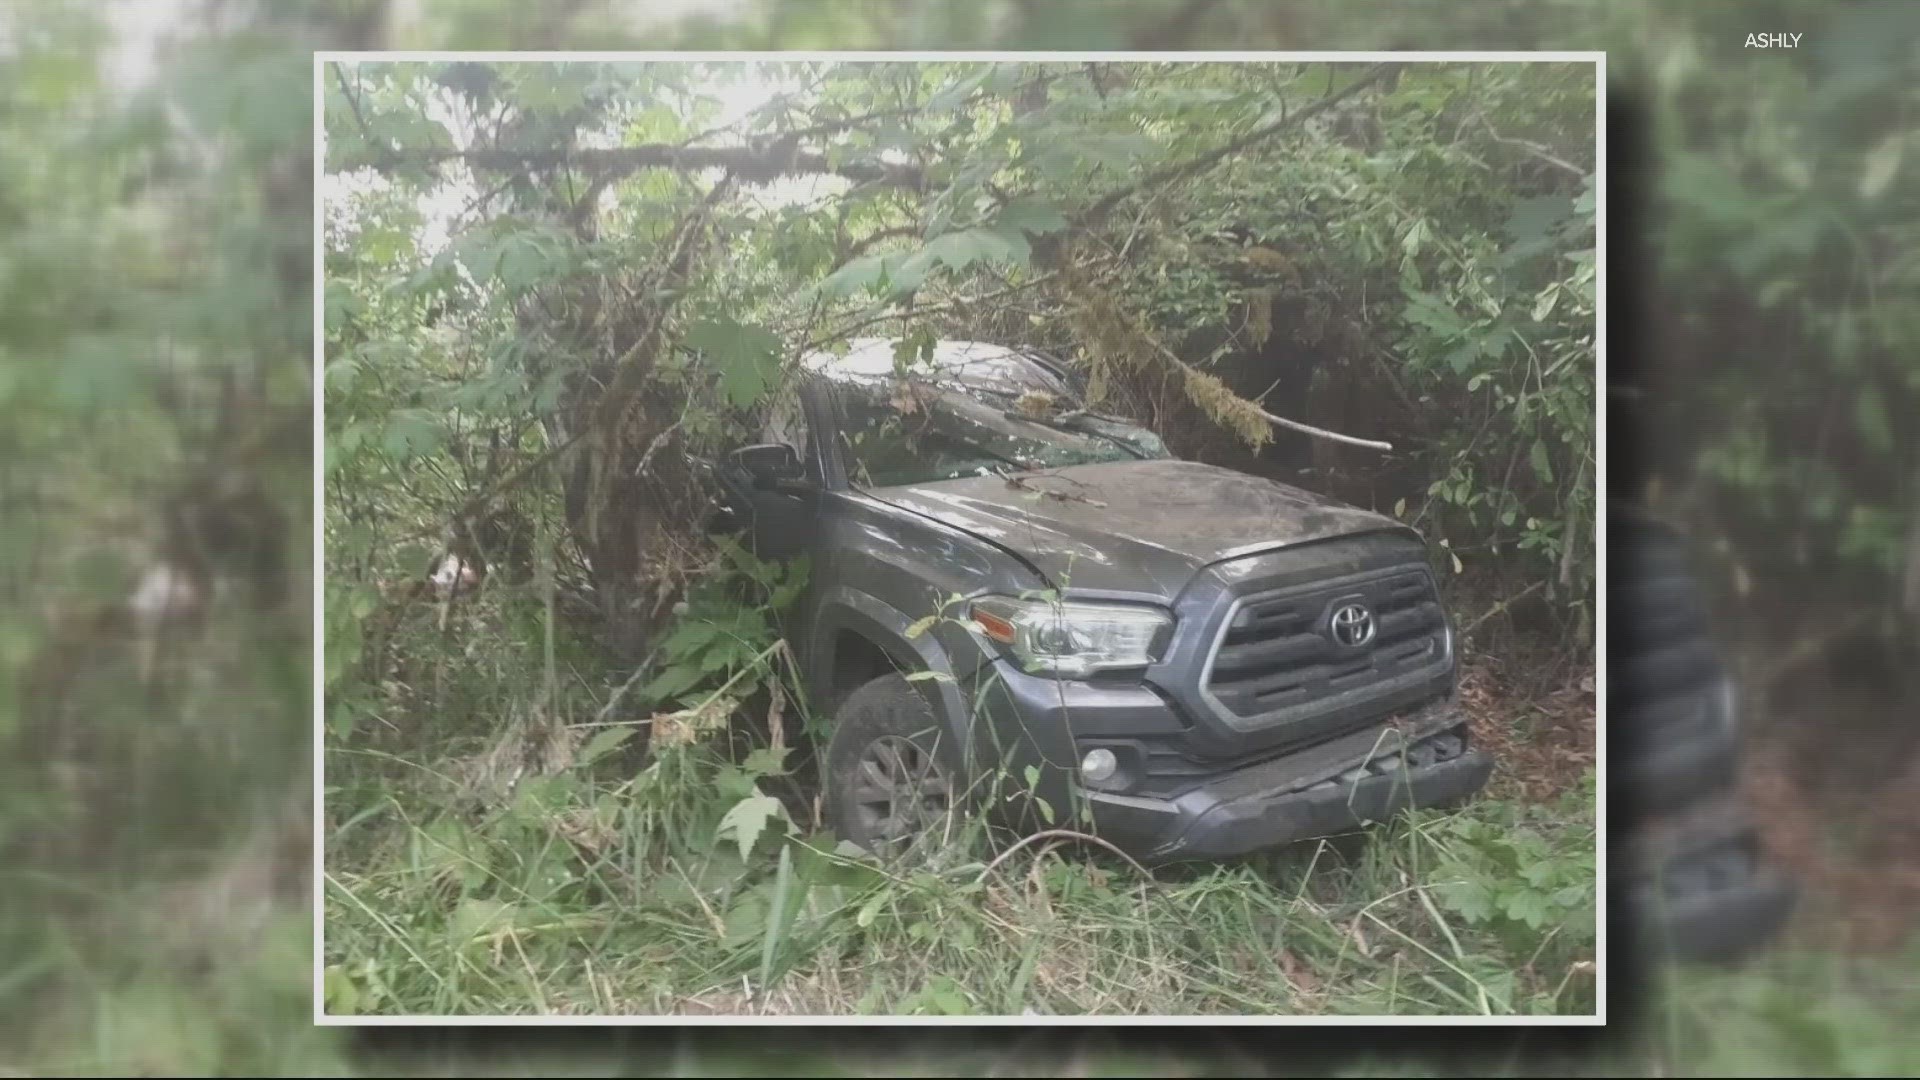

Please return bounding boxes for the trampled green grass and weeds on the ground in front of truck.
[326,768,1594,1015]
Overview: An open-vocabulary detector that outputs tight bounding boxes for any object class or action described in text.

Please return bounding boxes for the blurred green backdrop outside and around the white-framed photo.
[0,0,1920,1074]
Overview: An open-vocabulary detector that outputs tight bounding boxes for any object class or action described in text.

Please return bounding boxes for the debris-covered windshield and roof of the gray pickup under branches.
[814,338,1169,486]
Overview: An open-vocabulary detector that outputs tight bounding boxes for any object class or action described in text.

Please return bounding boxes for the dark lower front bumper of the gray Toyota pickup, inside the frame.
[1081,707,1494,863]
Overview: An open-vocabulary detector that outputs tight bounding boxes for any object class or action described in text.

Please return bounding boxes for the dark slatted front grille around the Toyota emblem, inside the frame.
[1206,567,1446,719]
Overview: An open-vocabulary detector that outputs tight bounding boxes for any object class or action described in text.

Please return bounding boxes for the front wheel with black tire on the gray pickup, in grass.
[824,675,960,857]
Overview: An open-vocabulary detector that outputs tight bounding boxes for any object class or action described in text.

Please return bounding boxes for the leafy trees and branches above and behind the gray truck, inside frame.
[324,61,1596,675]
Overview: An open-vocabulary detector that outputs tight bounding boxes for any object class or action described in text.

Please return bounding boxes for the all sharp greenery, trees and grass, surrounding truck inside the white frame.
[323,61,1596,1015]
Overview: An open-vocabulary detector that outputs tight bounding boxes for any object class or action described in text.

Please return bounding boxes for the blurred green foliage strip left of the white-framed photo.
[0,4,332,1072]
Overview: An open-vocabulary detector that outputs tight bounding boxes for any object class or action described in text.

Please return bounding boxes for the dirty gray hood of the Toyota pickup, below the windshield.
[868,459,1411,600]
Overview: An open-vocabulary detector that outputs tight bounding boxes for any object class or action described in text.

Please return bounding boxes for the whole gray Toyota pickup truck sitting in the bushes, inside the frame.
[718,340,1492,863]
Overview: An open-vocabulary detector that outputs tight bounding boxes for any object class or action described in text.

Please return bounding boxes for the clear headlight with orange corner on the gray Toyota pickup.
[968,596,1173,678]
